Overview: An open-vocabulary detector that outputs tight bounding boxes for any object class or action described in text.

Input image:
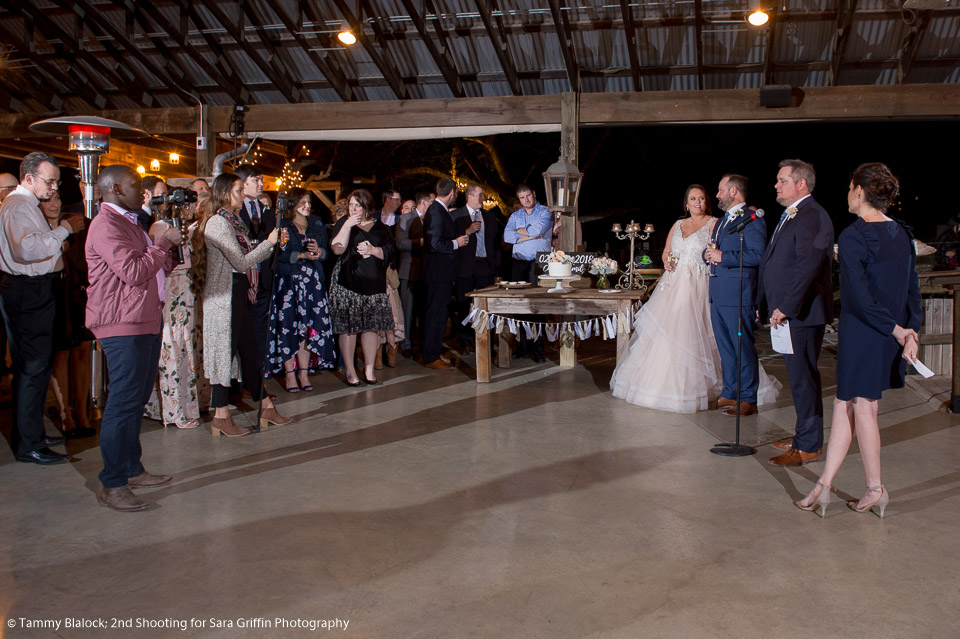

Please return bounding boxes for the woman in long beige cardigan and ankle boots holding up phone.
[193,173,293,437]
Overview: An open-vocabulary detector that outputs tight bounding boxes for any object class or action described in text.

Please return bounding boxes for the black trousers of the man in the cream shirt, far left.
[0,274,55,455]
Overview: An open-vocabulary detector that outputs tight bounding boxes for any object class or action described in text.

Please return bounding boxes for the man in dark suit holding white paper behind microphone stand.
[757,160,833,466]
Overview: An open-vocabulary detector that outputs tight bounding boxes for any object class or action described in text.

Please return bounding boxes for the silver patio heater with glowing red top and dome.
[30,115,148,408]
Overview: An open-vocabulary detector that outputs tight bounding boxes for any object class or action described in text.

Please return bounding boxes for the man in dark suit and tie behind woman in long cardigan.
[234,164,277,361]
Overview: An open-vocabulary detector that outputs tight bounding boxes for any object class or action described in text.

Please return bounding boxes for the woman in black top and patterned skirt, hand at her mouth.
[330,189,395,386]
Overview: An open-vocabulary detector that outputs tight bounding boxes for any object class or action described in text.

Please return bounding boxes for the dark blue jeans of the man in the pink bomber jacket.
[100,333,161,488]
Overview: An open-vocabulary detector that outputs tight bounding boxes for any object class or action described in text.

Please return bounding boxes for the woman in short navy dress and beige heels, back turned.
[794,162,921,517]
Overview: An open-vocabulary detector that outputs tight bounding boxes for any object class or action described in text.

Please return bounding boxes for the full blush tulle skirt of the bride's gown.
[610,265,723,413]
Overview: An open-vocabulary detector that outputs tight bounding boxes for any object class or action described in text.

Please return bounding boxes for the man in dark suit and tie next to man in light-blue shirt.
[451,184,501,354]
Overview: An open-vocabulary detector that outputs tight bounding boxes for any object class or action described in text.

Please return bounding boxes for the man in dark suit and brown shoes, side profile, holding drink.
[423,178,467,370]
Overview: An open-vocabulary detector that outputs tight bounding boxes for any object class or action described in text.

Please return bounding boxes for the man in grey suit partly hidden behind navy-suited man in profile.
[396,193,433,357]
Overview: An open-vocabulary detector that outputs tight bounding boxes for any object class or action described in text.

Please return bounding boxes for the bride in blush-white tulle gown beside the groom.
[610,184,780,413]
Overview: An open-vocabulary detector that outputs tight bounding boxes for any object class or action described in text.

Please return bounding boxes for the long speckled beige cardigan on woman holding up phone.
[203,215,273,386]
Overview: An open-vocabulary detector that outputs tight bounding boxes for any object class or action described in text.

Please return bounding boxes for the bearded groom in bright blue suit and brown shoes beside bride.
[703,173,767,416]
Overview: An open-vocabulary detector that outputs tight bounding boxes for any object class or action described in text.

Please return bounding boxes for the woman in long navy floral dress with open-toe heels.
[269,188,337,393]
